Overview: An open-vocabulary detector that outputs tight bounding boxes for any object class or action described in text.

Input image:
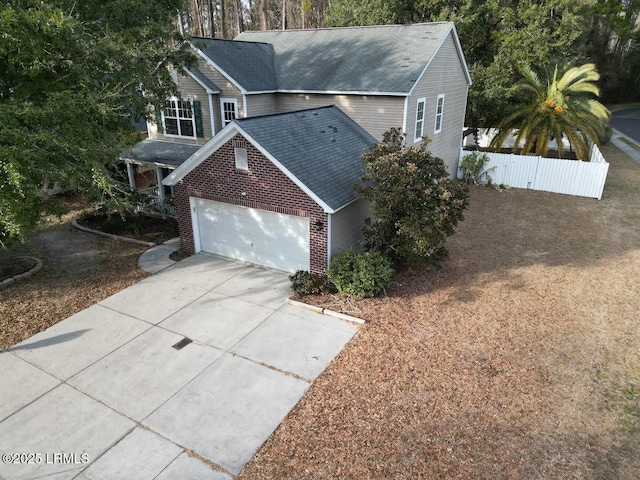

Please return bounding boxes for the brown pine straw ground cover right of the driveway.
[239,147,640,480]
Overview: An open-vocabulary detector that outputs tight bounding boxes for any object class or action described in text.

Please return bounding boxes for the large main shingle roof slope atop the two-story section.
[236,22,453,94]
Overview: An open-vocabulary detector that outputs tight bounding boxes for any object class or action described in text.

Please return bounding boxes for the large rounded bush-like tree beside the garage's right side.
[355,129,469,264]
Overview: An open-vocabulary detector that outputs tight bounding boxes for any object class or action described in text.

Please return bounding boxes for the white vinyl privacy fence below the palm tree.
[458,145,609,200]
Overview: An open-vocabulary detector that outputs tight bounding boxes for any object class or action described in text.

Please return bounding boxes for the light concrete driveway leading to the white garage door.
[0,254,357,480]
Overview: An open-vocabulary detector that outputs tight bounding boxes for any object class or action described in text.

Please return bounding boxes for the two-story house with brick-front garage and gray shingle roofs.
[121,23,471,272]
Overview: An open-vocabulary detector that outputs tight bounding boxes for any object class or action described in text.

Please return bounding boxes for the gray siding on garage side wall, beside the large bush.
[329,199,371,263]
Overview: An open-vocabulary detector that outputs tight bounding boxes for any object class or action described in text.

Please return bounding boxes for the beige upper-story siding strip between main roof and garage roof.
[276,93,404,140]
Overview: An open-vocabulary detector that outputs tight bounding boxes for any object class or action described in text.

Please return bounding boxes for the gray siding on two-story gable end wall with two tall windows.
[406,34,469,176]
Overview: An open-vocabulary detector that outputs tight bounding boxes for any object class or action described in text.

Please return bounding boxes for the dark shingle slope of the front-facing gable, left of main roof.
[191,37,278,92]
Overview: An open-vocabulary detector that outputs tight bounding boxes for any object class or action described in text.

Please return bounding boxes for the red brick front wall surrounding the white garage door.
[174,135,328,273]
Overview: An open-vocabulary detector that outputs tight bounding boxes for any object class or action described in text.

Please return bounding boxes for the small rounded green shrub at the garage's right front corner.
[327,250,393,298]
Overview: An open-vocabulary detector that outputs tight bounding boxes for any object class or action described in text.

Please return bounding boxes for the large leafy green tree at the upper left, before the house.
[0,0,191,248]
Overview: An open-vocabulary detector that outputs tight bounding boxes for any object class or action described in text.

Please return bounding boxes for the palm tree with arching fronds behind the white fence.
[491,63,610,160]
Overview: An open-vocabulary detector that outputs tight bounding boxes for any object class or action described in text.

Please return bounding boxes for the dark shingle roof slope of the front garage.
[236,106,377,211]
